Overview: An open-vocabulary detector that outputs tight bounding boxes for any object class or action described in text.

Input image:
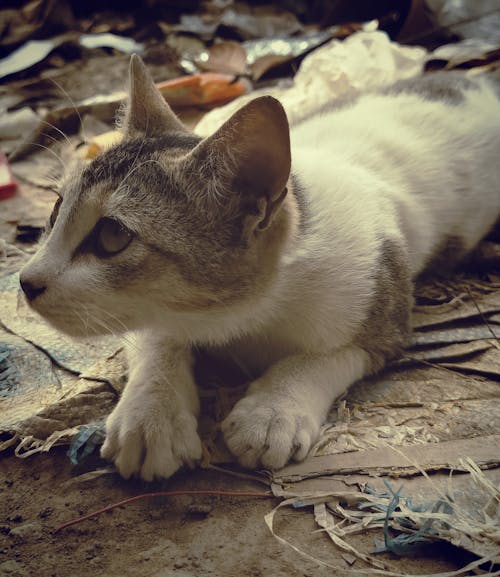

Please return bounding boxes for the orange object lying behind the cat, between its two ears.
[156,72,248,107]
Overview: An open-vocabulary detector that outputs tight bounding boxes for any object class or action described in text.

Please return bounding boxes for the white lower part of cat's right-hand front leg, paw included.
[222,346,373,469]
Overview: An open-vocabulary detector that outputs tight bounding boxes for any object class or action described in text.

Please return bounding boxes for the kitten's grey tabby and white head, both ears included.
[20,56,290,336]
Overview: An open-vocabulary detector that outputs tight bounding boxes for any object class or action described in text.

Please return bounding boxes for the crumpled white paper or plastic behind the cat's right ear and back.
[195,30,427,136]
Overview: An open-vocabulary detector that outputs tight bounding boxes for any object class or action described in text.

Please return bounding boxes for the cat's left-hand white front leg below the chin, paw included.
[101,333,202,481]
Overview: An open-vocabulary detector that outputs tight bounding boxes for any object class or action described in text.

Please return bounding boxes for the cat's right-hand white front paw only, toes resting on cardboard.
[222,391,321,469]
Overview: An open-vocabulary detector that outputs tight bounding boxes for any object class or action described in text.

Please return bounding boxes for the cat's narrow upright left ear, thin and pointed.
[122,54,187,137]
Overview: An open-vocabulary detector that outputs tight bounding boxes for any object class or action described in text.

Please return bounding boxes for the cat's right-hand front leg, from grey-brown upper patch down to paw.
[223,239,412,469]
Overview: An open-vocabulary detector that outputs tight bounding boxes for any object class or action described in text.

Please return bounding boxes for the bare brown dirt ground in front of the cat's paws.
[0,448,467,577]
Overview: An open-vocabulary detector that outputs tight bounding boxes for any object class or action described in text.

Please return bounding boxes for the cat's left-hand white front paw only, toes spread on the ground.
[101,398,202,481]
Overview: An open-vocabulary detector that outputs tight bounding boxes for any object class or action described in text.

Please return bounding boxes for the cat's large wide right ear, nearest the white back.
[190,96,291,239]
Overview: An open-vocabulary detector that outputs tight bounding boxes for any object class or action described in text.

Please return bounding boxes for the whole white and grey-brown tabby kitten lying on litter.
[20,56,500,480]
